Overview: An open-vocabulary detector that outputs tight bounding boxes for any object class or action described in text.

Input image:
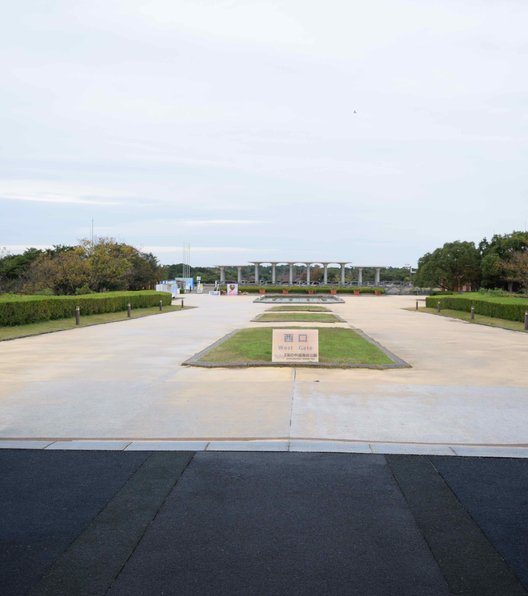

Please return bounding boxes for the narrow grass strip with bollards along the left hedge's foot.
[0,305,194,341]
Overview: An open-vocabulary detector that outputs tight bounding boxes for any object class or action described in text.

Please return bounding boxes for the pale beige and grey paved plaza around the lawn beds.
[0,295,528,456]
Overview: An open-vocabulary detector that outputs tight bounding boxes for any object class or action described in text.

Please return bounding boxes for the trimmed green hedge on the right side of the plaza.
[425,292,528,322]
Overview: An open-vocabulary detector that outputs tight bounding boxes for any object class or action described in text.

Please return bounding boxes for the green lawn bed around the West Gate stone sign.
[192,327,394,366]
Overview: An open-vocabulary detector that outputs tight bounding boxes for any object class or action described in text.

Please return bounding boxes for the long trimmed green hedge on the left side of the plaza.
[0,290,172,326]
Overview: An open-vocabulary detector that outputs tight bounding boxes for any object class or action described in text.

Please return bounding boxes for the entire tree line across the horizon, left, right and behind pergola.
[6,231,528,295]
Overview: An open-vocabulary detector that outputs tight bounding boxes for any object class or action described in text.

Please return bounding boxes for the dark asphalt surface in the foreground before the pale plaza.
[0,450,528,596]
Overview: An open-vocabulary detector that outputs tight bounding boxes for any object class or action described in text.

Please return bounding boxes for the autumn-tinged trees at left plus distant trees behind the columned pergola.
[0,238,411,295]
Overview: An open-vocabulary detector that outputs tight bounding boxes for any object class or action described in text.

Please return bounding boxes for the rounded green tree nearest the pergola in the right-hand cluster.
[415,241,481,291]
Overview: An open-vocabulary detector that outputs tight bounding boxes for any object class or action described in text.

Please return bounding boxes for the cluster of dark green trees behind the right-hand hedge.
[414,231,528,292]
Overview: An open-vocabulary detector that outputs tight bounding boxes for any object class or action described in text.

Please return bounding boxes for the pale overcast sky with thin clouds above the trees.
[0,0,528,266]
